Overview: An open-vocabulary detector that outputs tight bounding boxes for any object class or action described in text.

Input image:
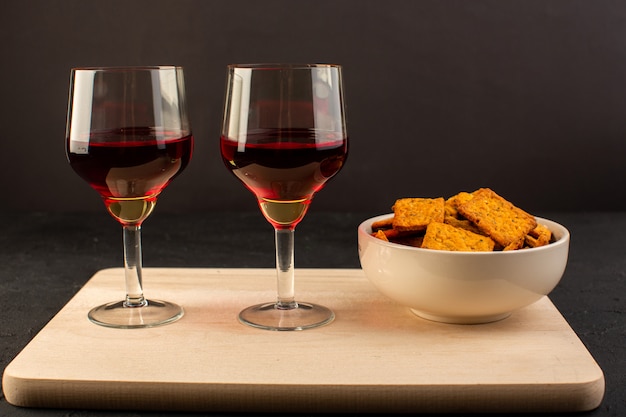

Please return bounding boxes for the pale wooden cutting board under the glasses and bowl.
[3,268,604,413]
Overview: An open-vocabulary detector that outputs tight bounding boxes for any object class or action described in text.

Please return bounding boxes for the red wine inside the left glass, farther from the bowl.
[67,128,193,223]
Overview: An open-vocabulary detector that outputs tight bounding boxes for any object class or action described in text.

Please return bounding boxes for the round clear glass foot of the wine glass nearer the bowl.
[239,302,335,331]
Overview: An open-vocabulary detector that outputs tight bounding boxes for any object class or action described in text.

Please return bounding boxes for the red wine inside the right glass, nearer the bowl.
[220,129,348,227]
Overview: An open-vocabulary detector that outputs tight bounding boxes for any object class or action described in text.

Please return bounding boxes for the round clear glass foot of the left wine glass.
[88,300,184,329]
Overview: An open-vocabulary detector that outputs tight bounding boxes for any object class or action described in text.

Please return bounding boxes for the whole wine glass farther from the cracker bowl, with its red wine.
[66,66,193,328]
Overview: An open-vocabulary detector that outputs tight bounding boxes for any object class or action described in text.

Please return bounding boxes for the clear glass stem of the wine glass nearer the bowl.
[275,229,298,310]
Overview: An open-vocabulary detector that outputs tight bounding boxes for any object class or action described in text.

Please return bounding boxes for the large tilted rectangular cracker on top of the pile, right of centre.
[458,188,537,248]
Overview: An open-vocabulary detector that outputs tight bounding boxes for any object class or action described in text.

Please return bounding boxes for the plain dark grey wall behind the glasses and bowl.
[0,0,626,215]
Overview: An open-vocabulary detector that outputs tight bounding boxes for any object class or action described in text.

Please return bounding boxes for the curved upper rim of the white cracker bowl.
[357,213,570,256]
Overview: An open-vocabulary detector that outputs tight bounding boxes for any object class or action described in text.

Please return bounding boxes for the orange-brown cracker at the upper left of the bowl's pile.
[392,197,444,232]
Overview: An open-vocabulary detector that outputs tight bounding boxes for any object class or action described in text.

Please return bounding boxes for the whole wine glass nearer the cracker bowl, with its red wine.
[220,64,348,330]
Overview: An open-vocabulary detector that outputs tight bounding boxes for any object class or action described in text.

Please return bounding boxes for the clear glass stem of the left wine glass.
[124,225,147,307]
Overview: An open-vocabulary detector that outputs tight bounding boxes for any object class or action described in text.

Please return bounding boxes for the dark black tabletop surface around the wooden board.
[0,209,626,417]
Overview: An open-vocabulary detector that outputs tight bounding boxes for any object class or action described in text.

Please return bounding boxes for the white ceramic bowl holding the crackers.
[358,214,570,324]
